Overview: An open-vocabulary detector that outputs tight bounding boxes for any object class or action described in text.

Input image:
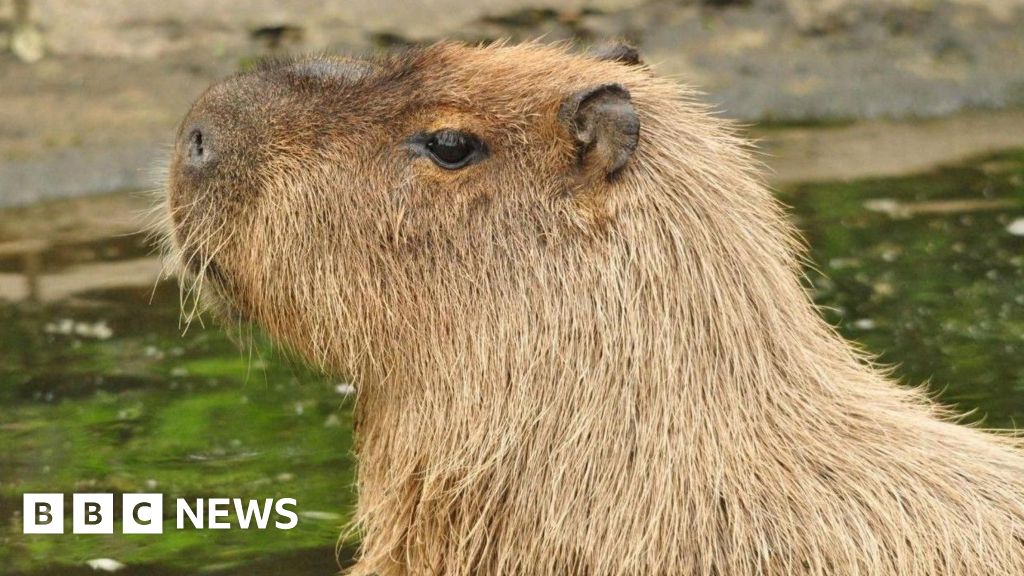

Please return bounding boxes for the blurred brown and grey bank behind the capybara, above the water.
[0,0,1024,205]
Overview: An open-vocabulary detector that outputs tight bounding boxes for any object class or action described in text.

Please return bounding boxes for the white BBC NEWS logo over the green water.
[22,493,299,534]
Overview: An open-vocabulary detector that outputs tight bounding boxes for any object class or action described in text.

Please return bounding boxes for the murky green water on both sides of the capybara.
[0,151,1024,574]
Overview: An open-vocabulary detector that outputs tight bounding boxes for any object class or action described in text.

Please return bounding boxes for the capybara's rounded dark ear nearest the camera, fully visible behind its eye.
[558,84,640,178]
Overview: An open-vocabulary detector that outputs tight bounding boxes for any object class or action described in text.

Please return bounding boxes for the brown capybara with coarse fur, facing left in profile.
[155,43,1024,576]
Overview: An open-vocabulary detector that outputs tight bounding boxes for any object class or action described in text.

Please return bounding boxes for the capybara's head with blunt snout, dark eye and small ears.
[168,44,765,371]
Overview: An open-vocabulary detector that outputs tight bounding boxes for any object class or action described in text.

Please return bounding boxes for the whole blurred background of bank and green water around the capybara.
[0,0,1024,575]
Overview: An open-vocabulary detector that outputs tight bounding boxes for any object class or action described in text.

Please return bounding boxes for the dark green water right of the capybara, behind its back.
[783,151,1024,427]
